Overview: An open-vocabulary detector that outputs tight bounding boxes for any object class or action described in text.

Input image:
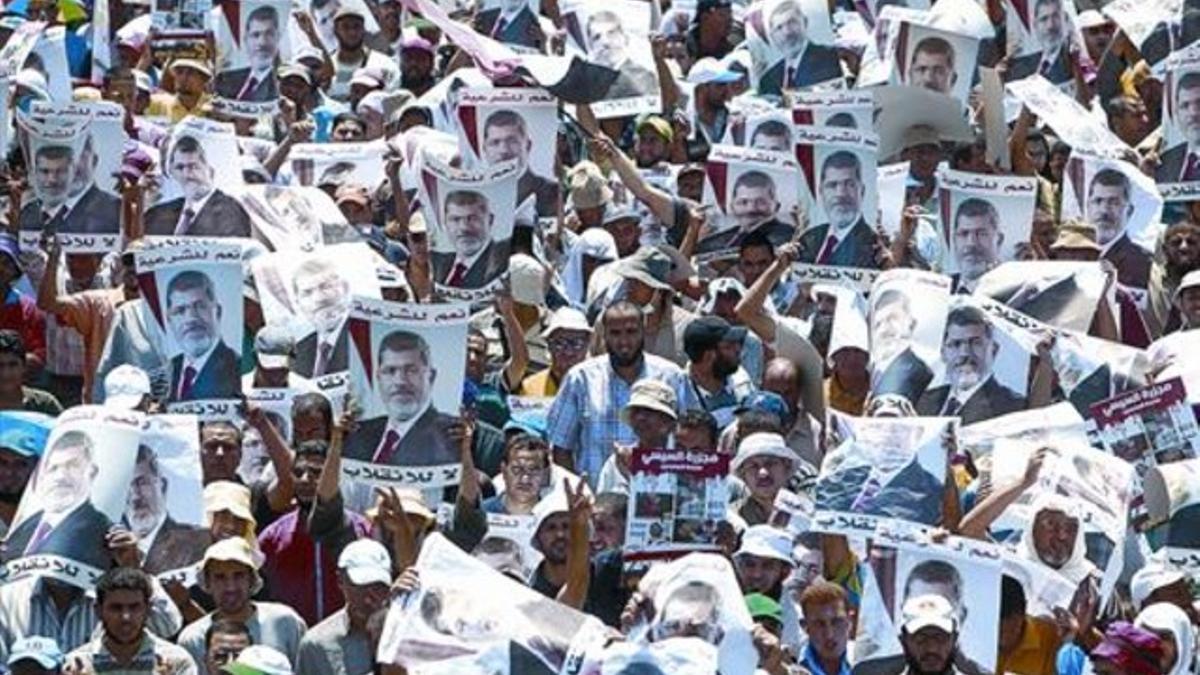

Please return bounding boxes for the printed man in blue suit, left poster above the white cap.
[164,270,241,401]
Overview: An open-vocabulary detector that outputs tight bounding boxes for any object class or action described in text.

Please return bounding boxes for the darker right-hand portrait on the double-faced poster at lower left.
[125,446,211,574]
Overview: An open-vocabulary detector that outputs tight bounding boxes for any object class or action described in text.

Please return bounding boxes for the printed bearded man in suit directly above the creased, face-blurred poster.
[917,305,1025,424]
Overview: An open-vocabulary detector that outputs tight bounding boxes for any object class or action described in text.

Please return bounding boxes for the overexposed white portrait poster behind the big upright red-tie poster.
[251,243,380,378]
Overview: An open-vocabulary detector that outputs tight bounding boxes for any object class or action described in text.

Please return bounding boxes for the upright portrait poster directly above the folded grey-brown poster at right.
[937,169,1038,293]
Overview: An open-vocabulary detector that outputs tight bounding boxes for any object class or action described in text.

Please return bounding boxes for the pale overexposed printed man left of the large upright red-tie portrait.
[292,257,350,378]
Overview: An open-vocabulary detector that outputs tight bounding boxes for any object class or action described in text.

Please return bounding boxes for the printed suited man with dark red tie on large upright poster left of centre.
[346,330,458,466]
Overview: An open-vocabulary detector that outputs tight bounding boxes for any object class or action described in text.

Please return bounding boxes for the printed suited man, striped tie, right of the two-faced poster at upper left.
[145,136,250,237]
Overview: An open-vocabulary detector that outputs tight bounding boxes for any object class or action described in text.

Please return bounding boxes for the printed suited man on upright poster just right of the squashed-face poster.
[800,150,880,269]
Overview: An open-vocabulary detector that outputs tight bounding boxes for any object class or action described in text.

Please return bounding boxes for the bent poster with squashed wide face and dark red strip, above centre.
[696,145,809,253]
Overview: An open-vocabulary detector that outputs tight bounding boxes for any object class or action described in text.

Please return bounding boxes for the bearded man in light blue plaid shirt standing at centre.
[546,300,700,476]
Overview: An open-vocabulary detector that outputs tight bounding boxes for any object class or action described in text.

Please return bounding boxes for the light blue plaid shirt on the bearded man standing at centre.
[547,354,700,480]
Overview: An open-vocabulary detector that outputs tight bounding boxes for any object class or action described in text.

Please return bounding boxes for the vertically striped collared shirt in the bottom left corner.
[0,569,184,663]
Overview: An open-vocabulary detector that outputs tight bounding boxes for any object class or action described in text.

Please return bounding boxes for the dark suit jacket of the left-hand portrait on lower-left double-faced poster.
[4,501,113,569]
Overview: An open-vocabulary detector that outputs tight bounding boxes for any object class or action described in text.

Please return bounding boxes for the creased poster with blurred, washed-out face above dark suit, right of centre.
[814,417,956,536]
